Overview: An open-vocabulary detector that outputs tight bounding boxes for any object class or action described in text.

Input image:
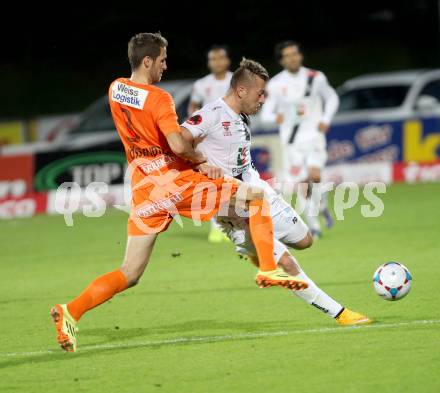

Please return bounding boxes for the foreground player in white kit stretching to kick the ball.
[182,59,371,325]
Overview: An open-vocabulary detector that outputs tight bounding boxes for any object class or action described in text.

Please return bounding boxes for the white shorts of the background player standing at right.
[283,138,327,182]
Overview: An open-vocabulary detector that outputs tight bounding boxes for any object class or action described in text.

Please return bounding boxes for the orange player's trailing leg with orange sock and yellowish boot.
[50,234,157,352]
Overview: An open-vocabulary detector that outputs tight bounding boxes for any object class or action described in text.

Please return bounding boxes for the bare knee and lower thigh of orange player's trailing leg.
[121,233,157,286]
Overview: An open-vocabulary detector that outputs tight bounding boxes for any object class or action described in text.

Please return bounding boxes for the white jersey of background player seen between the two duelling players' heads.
[191,71,232,106]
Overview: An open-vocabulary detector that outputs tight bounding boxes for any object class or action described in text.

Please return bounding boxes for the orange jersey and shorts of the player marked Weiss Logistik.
[109,78,238,236]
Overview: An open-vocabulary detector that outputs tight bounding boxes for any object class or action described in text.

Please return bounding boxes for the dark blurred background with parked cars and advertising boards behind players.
[0,0,440,218]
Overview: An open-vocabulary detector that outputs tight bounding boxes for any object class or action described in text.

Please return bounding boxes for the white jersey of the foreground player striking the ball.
[182,98,288,215]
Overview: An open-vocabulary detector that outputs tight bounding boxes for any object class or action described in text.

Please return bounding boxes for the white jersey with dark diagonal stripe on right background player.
[262,67,339,146]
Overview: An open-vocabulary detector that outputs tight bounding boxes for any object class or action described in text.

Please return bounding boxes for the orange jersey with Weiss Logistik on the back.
[109,78,191,185]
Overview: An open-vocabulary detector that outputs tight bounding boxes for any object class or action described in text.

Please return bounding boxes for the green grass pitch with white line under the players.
[0,184,440,393]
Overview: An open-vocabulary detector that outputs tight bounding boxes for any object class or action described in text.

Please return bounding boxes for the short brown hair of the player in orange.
[128,32,168,71]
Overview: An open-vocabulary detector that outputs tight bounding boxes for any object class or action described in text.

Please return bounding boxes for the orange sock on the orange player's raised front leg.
[249,199,277,272]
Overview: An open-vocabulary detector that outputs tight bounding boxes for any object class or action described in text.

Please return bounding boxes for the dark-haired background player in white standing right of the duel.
[261,41,339,239]
